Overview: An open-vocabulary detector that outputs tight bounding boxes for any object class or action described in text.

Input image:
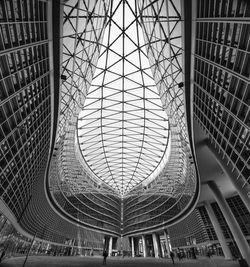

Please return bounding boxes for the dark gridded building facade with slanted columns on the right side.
[172,1,250,261]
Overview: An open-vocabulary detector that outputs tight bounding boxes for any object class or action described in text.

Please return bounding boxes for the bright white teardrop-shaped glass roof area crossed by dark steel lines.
[78,0,169,196]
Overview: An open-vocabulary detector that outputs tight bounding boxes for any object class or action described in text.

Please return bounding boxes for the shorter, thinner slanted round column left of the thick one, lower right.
[205,202,233,260]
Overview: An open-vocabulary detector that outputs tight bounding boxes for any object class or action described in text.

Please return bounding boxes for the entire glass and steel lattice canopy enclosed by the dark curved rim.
[49,0,197,233]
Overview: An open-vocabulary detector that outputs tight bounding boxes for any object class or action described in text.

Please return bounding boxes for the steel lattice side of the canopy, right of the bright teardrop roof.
[138,0,188,143]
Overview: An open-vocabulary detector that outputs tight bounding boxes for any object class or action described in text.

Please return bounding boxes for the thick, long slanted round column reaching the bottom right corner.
[208,181,250,265]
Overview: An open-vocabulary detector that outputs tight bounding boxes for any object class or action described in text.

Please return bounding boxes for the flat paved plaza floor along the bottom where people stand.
[0,256,240,267]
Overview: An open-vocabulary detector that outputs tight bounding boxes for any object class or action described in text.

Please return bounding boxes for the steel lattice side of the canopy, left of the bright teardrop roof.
[58,0,108,138]
